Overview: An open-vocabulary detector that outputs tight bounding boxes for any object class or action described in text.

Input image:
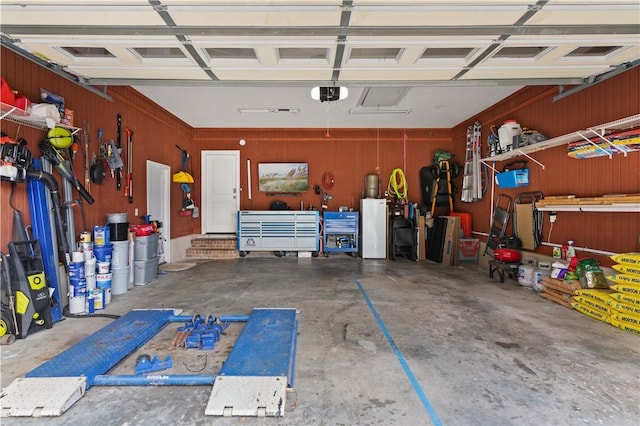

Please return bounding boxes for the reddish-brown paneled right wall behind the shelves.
[453,67,640,263]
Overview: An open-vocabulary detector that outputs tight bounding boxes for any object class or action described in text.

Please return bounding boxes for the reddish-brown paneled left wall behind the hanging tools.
[0,48,194,251]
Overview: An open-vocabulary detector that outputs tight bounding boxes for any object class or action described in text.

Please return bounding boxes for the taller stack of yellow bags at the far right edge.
[607,253,640,335]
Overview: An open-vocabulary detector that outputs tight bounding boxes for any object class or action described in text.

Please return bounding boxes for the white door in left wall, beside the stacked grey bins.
[146,160,171,263]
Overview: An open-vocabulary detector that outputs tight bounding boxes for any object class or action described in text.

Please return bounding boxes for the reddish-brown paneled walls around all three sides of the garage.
[0,48,640,264]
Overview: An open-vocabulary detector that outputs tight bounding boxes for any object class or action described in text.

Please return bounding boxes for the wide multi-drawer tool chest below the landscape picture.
[238,210,320,251]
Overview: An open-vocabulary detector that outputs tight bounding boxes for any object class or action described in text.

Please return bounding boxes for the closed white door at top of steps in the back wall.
[200,150,240,234]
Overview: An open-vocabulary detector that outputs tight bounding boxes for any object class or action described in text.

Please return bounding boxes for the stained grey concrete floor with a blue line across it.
[0,254,640,425]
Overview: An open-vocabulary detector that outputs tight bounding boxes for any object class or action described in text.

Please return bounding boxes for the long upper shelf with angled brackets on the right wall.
[480,114,640,169]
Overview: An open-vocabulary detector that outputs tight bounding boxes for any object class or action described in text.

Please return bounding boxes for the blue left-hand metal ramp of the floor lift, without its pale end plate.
[25,310,174,389]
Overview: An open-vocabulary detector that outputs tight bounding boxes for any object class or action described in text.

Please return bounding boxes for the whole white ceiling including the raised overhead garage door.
[0,0,640,127]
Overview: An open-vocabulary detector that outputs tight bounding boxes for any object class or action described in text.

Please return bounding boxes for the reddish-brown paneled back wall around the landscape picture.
[194,129,453,223]
